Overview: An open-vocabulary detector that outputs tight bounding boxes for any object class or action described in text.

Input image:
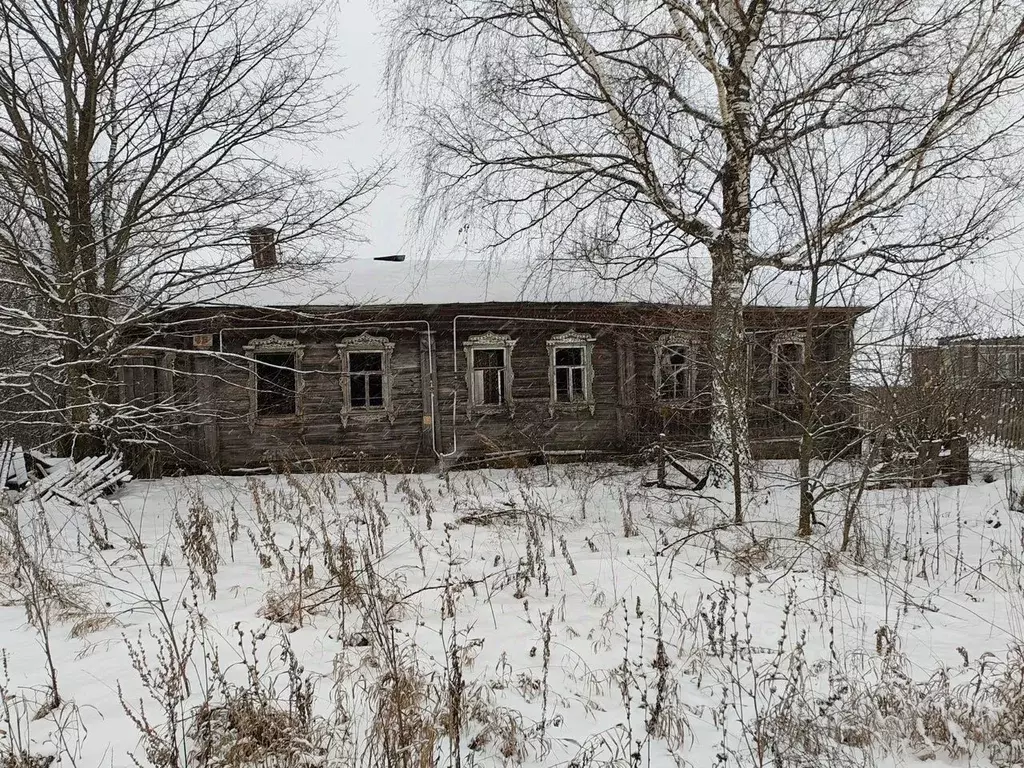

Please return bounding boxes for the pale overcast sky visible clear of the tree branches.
[321,0,1024,303]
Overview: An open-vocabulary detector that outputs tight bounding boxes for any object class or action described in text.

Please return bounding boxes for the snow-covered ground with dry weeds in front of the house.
[0,460,1024,768]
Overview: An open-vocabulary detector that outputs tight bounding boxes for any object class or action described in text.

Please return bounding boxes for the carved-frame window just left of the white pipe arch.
[337,334,395,427]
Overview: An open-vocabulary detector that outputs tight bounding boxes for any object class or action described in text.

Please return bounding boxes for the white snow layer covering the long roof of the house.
[188,259,860,307]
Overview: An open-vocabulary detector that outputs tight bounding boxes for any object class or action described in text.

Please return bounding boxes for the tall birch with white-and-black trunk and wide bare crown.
[388,0,1024,484]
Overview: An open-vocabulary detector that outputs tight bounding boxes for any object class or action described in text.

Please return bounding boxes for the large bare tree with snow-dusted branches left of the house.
[0,0,382,455]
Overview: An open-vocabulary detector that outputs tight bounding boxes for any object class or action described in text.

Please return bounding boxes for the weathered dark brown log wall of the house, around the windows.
[134,304,853,469]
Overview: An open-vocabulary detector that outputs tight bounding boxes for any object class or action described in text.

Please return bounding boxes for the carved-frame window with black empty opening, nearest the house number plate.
[245,336,303,429]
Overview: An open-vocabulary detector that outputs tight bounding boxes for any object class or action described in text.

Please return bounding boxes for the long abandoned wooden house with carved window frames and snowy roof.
[123,240,872,471]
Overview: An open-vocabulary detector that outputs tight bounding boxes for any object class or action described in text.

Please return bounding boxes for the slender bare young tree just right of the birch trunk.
[772,120,1014,536]
